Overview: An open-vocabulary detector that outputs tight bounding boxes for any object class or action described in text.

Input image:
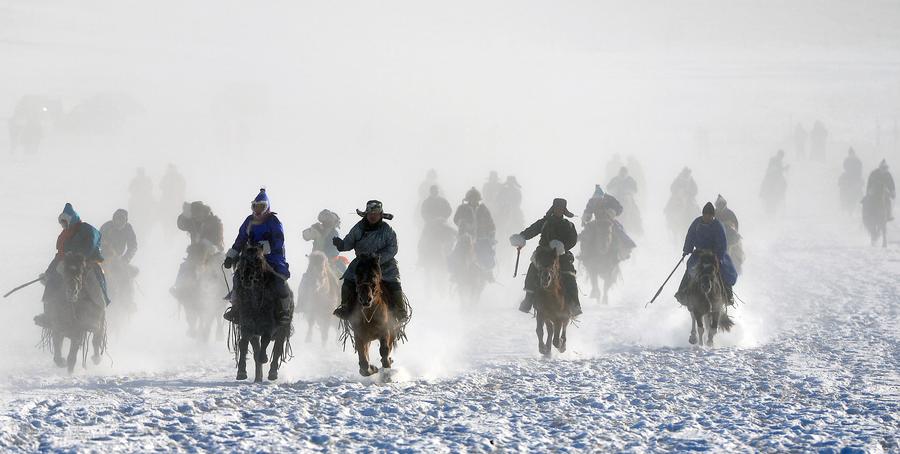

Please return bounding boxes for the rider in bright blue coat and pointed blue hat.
[223,188,294,324]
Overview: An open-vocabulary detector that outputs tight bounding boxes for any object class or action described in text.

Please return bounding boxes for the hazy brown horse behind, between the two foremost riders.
[296,251,341,345]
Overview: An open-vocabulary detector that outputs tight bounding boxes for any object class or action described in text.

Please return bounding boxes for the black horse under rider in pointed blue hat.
[232,244,293,383]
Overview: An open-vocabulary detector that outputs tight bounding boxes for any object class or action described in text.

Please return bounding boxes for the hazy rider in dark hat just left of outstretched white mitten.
[453,188,497,281]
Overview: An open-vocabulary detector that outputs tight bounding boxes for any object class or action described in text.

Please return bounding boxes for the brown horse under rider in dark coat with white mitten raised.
[531,246,571,357]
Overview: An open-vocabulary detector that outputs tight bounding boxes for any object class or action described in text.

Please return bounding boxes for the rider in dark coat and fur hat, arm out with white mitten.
[509,198,582,317]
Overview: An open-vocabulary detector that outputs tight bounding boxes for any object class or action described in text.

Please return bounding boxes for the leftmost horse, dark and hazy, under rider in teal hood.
[45,252,106,374]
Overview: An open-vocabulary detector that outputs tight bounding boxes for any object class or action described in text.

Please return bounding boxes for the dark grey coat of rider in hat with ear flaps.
[338,219,400,282]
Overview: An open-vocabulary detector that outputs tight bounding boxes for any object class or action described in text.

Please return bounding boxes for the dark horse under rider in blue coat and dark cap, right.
[681,249,734,347]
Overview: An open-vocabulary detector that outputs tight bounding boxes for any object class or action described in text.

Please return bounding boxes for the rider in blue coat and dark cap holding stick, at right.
[675,202,737,304]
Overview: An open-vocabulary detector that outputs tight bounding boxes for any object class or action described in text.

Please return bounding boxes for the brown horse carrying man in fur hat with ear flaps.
[341,254,405,377]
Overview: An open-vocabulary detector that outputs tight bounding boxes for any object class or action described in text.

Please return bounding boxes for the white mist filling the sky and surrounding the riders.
[0,0,900,449]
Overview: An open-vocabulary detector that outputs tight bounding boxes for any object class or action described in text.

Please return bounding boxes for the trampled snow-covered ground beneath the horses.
[0,216,900,452]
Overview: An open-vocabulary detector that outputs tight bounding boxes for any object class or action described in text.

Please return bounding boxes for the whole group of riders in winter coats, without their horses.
[26,149,895,372]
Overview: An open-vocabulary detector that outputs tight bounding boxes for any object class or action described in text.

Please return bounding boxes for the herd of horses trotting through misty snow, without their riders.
[37,199,733,382]
